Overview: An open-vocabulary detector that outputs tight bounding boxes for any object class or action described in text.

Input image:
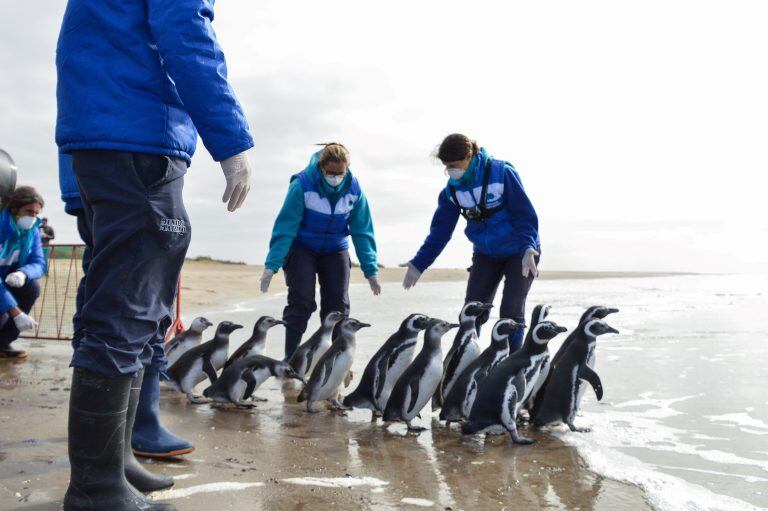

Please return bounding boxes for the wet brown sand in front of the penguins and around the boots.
[0,341,648,511]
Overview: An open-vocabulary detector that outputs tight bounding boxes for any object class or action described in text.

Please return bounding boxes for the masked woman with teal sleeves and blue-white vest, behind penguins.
[261,143,381,360]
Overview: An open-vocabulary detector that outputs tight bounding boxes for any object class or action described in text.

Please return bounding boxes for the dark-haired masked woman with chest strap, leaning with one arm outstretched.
[401,133,541,351]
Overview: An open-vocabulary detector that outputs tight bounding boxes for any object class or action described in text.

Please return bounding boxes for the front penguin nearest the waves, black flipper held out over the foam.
[533,319,619,432]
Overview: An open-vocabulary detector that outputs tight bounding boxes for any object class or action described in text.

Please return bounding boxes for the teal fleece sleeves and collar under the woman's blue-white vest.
[265,153,379,277]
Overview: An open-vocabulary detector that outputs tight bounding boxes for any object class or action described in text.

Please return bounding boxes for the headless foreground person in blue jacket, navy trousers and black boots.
[56,0,253,510]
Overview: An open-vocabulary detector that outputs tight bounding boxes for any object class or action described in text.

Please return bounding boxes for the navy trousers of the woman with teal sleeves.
[283,243,352,358]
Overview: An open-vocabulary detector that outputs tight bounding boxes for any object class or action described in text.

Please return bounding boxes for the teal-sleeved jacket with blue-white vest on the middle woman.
[265,151,378,277]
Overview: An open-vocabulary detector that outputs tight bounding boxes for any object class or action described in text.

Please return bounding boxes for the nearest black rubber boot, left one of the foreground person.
[64,367,176,511]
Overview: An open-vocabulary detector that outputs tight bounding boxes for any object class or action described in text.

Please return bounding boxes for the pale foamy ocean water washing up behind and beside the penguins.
[192,275,768,510]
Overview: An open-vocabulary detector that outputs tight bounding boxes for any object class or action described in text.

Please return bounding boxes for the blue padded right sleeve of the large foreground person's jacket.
[147,0,253,161]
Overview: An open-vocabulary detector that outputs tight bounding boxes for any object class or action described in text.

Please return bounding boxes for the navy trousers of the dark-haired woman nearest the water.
[464,250,540,351]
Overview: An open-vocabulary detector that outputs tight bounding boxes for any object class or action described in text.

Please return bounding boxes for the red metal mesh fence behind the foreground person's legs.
[22,244,184,340]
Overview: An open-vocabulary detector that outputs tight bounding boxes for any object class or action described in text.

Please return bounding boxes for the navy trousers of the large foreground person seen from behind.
[72,150,191,376]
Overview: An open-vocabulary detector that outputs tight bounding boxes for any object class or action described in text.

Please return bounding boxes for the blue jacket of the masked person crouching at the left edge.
[0,209,45,312]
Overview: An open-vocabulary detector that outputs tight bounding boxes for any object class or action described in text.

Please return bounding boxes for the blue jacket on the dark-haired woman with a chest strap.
[411,149,540,272]
